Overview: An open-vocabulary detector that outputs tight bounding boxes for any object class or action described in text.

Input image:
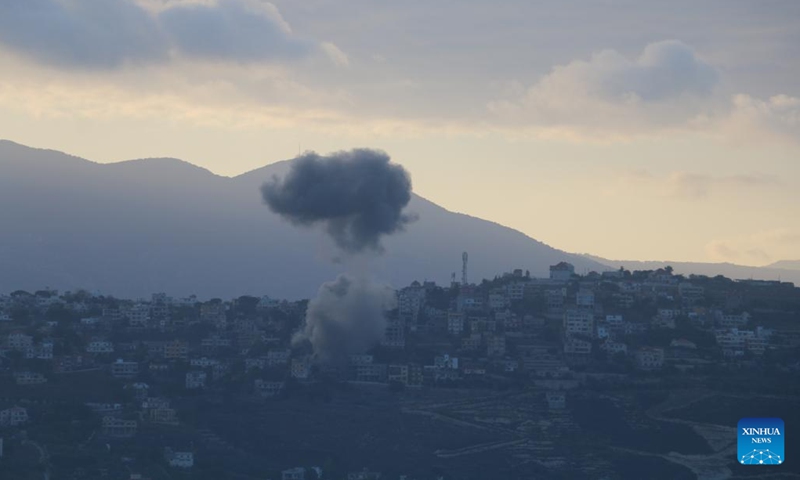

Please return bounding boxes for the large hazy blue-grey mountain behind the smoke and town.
[0,141,605,298]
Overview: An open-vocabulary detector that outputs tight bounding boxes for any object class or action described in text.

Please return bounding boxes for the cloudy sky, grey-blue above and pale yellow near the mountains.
[0,0,800,265]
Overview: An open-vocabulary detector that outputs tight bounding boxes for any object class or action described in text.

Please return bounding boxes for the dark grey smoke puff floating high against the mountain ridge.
[261,149,413,253]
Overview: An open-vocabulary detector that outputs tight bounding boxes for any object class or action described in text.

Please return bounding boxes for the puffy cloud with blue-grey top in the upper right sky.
[489,40,719,135]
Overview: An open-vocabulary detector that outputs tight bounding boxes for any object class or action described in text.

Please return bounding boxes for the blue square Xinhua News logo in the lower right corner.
[737,418,786,465]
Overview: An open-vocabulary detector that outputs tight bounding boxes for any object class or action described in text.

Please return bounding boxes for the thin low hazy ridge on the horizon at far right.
[584,254,800,286]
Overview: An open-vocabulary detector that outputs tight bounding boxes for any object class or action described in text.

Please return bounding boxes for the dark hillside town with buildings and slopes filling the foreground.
[0,262,800,480]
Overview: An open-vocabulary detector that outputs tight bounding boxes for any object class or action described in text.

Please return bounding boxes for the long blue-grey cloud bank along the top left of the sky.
[0,0,346,69]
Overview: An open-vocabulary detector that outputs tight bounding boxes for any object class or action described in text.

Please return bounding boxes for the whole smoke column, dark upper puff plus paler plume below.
[261,149,414,363]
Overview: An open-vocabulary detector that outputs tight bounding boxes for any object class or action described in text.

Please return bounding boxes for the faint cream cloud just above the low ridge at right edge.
[706,227,800,265]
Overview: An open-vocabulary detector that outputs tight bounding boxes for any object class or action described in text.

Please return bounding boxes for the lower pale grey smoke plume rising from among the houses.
[293,275,396,363]
